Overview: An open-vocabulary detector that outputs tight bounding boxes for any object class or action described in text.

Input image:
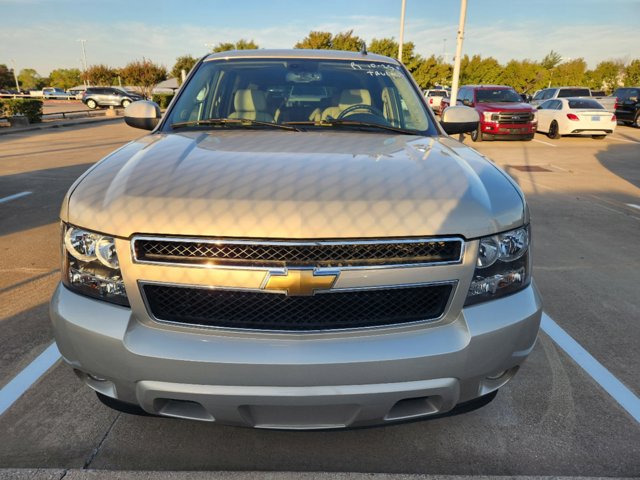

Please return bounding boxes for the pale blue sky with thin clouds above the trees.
[0,0,640,76]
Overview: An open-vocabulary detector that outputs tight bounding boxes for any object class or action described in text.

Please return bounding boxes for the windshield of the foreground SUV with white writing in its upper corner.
[165,59,437,135]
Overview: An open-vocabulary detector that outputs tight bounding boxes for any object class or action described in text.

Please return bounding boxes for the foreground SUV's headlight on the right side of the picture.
[465,226,531,306]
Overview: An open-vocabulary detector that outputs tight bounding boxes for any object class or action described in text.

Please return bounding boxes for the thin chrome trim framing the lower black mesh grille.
[137,280,458,335]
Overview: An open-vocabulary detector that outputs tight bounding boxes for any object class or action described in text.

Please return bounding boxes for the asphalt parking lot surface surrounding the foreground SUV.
[0,121,640,478]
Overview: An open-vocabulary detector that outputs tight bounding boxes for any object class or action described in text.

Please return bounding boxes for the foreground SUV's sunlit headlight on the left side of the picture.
[62,225,129,306]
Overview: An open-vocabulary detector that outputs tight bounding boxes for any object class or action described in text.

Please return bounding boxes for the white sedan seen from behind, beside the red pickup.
[538,97,616,140]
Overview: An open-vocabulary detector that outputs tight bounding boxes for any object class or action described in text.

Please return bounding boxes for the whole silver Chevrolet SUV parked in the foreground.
[51,50,542,429]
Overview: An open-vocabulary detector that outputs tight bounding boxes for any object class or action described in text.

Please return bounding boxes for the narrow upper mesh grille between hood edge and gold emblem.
[132,236,464,268]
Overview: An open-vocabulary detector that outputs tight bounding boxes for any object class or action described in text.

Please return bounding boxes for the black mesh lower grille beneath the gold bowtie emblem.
[142,284,453,331]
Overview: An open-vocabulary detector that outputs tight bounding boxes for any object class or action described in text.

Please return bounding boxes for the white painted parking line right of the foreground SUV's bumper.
[540,313,640,423]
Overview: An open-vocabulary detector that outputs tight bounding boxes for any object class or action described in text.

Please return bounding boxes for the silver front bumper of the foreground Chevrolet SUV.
[51,283,542,429]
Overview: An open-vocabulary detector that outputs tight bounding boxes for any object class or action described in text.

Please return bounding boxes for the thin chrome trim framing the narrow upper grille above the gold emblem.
[129,235,466,271]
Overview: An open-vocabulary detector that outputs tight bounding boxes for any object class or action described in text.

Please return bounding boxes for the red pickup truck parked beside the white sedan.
[440,85,538,142]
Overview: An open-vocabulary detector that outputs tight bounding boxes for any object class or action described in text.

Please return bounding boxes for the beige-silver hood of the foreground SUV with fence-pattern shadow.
[62,130,525,239]
